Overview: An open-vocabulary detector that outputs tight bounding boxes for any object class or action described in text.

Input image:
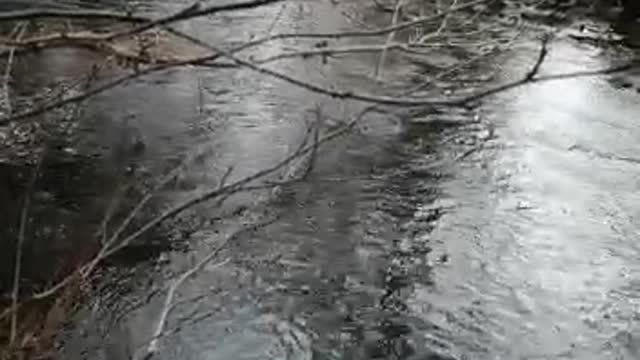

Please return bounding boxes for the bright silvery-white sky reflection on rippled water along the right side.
[422,43,640,359]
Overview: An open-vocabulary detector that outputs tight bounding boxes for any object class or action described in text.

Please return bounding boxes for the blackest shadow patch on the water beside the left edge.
[0,132,182,294]
